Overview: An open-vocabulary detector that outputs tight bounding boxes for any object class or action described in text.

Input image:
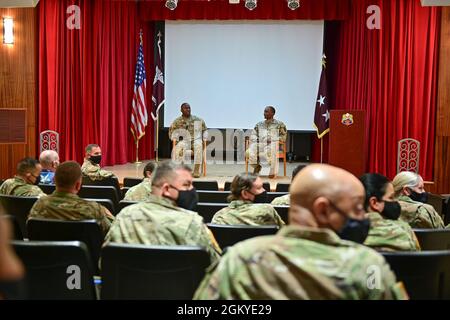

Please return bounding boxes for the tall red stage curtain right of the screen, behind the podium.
[314,0,440,180]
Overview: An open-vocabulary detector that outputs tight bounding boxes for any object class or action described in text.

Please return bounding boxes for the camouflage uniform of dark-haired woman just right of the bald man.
[364,212,420,251]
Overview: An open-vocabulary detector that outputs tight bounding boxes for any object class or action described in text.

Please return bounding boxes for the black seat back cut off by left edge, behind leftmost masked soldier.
[0,194,38,238]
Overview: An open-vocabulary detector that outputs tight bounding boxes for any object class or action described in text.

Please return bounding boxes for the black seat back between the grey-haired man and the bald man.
[208,223,278,249]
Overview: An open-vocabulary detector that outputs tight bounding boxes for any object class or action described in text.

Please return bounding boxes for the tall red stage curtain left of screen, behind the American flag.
[38,0,154,165]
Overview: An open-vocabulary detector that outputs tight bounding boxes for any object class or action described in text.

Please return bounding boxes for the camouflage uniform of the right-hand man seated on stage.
[247,119,287,174]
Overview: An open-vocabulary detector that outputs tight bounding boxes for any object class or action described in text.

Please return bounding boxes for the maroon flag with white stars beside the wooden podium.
[314,55,330,139]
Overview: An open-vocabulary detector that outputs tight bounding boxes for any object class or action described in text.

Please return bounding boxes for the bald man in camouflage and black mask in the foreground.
[194,164,407,300]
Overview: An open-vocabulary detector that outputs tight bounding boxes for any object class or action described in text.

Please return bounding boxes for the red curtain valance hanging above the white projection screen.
[140,0,350,21]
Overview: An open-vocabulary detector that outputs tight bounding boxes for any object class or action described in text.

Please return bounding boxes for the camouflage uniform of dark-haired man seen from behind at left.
[28,191,114,235]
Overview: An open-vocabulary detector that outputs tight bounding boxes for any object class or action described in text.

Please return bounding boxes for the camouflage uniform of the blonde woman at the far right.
[398,195,444,229]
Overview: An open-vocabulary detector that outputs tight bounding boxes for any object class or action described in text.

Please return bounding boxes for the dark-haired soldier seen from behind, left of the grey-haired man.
[29,161,114,235]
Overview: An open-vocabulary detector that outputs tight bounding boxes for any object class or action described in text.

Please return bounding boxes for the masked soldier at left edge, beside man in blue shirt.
[0,158,45,197]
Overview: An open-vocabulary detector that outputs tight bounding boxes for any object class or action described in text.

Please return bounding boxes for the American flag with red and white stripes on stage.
[131,31,148,141]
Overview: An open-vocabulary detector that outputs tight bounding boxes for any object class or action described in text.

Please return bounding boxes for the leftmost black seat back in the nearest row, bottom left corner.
[12,241,95,300]
